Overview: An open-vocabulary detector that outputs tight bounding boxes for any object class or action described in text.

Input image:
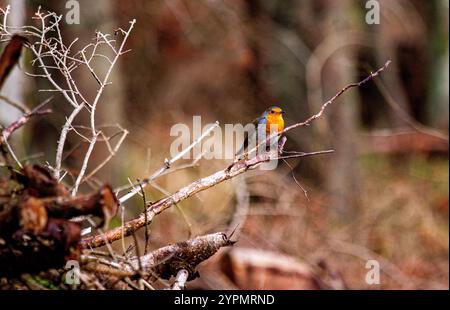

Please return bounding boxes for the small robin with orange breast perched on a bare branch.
[236,106,285,158]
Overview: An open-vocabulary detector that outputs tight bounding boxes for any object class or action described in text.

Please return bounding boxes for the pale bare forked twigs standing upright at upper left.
[0,5,136,186]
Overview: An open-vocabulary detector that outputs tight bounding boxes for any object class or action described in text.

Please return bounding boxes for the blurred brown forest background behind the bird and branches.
[0,0,449,289]
